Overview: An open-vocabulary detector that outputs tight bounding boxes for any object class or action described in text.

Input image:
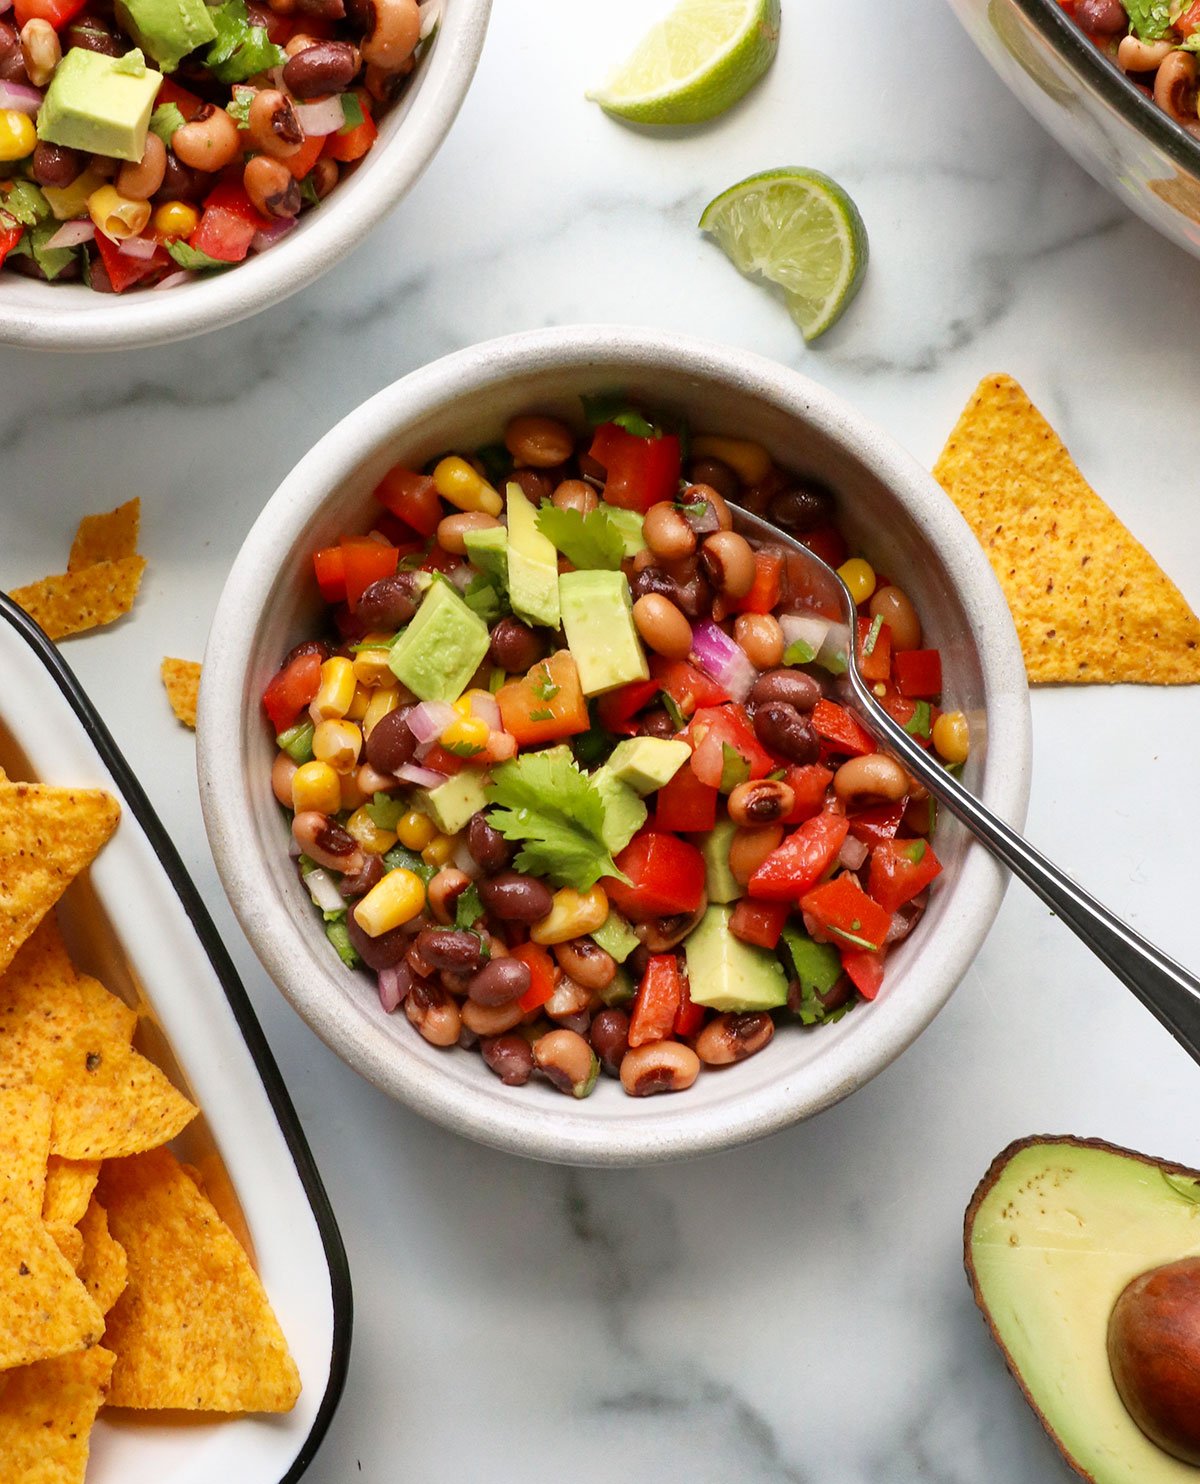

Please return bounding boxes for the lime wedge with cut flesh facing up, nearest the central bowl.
[700,169,868,340]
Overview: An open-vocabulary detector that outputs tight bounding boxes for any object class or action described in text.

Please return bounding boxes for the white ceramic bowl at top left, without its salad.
[0,0,491,350]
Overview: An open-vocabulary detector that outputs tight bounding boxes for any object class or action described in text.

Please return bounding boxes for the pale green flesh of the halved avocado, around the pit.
[966,1138,1200,1484]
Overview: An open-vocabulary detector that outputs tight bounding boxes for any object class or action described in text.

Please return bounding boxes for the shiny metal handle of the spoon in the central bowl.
[848,672,1200,1061]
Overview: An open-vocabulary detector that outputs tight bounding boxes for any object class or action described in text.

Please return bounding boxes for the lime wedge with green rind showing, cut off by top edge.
[587,0,779,125]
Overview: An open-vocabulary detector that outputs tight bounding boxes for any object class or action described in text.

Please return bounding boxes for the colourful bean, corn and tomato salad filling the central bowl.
[263,398,970,1098]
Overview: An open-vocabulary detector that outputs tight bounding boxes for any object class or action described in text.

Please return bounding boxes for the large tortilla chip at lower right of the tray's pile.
[99,1149,300,1411]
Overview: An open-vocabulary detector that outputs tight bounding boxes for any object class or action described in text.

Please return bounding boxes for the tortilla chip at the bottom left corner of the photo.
[0,1345,114,1484]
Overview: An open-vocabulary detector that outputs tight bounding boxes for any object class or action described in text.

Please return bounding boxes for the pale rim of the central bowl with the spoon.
[196,325,1031,1165]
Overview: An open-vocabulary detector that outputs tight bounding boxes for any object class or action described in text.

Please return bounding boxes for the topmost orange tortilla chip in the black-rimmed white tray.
[0,779,120,972]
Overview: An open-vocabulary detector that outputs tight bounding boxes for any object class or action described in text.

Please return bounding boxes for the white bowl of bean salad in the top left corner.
[0,0,489,349]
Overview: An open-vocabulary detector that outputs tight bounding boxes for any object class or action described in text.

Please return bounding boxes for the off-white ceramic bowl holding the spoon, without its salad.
[197,326,1029,1165]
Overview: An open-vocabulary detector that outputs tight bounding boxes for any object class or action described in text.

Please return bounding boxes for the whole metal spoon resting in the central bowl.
[731,508,1200,1061]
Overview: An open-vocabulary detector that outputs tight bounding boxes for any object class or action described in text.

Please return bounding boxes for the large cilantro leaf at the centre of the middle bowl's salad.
[487,748,624,892]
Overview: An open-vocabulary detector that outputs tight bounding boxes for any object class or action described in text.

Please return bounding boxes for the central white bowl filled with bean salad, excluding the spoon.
[199,326,1028,1163]
